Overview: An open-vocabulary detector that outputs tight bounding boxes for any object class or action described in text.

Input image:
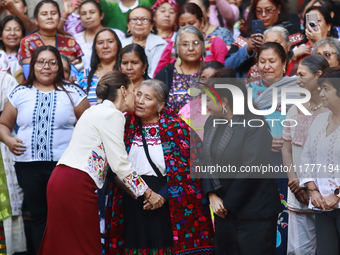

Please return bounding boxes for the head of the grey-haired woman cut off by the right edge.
[313,37,340,67]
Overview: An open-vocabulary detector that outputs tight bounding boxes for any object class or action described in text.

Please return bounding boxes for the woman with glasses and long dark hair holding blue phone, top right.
[224,0,304,78]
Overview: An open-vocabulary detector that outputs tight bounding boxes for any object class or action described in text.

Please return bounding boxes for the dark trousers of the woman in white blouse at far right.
[315,209,340,255]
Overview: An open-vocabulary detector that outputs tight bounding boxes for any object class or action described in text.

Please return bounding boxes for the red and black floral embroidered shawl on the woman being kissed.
[105,107,214,254]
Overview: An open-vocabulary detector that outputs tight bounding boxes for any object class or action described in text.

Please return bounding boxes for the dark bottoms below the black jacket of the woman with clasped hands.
[215,214,277,255]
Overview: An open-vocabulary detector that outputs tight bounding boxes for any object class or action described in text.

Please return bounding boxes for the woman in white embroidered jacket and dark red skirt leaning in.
[35,71,154,255]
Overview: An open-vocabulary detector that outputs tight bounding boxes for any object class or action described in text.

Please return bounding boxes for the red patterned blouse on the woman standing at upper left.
[20,33,84,61]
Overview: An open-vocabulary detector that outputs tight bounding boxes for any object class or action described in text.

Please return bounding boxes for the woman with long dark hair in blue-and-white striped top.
[78,28,122,106]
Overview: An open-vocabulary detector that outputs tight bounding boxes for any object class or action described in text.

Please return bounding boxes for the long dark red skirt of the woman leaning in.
[39,165,101,255]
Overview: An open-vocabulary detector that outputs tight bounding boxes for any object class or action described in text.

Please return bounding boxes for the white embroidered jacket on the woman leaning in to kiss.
[58,100,148,196]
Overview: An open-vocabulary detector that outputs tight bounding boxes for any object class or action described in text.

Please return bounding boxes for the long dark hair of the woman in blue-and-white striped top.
[86,27,122,93]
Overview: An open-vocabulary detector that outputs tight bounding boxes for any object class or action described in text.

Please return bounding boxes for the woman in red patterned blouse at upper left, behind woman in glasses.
[20,0,83,78]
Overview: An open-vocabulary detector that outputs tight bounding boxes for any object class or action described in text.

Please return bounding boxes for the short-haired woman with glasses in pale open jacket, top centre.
[122,6,167,77]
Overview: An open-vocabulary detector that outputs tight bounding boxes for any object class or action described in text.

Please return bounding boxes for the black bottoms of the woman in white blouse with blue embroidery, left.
[15,161,57,254]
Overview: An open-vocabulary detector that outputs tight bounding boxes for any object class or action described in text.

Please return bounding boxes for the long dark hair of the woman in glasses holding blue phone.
[241,0,289,37]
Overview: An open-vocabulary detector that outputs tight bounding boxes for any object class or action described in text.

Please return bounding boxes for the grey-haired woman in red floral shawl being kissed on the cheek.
[105,80,214,255]
